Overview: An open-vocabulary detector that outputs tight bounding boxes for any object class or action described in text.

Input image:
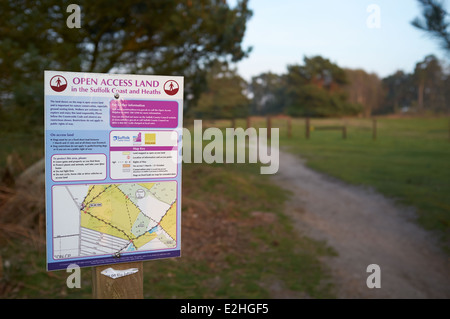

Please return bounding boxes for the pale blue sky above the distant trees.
[229,0,450,81]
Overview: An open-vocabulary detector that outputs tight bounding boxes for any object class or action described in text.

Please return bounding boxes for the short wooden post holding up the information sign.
[92,261,144,299]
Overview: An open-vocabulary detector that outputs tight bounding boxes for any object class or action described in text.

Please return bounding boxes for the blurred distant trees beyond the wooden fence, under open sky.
[189,55,450,118]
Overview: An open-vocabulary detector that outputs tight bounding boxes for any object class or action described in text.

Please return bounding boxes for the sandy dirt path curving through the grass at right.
[273,151,450,298]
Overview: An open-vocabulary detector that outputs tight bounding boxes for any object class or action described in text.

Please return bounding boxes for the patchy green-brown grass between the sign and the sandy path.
[140,158,334,298]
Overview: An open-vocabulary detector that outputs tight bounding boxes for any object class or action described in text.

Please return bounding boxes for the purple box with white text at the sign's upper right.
[110,100,178,128]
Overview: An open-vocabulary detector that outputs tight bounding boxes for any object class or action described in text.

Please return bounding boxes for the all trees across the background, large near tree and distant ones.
[0,0,450,131]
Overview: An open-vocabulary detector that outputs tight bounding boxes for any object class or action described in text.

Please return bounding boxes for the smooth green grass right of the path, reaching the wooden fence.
[251,117,450,251]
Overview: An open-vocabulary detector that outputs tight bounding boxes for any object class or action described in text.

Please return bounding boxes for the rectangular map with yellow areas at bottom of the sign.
[52,181,177,259]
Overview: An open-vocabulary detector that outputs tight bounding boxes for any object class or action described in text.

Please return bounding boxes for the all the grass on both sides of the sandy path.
[0,118,450,298]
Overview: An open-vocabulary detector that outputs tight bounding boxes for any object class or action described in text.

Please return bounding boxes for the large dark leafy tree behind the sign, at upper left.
[0,0,252,131]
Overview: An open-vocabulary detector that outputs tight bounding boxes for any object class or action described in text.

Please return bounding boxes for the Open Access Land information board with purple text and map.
[45,71,183,271]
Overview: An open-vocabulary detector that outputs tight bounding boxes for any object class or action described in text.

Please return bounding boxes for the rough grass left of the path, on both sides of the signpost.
[0,130,334,298]
